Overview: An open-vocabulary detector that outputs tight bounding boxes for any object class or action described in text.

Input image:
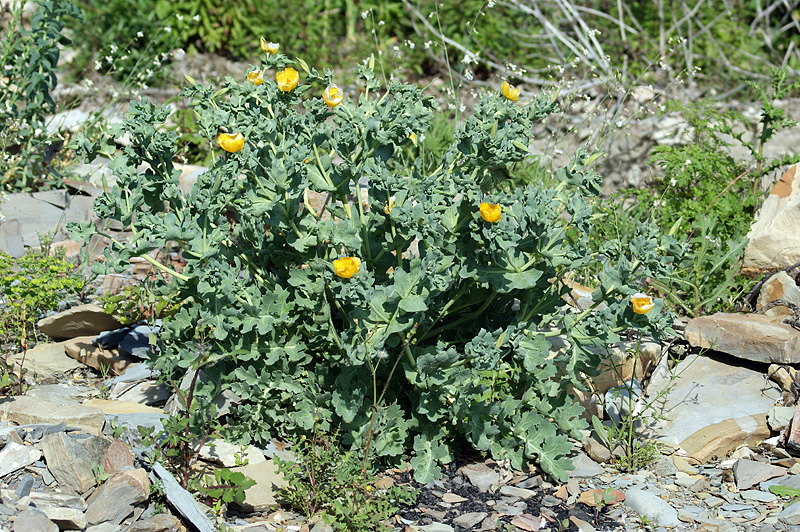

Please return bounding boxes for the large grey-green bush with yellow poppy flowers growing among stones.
[71,50,681,481]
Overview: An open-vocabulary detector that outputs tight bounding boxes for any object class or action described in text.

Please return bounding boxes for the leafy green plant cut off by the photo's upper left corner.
[0,0,80,191]
